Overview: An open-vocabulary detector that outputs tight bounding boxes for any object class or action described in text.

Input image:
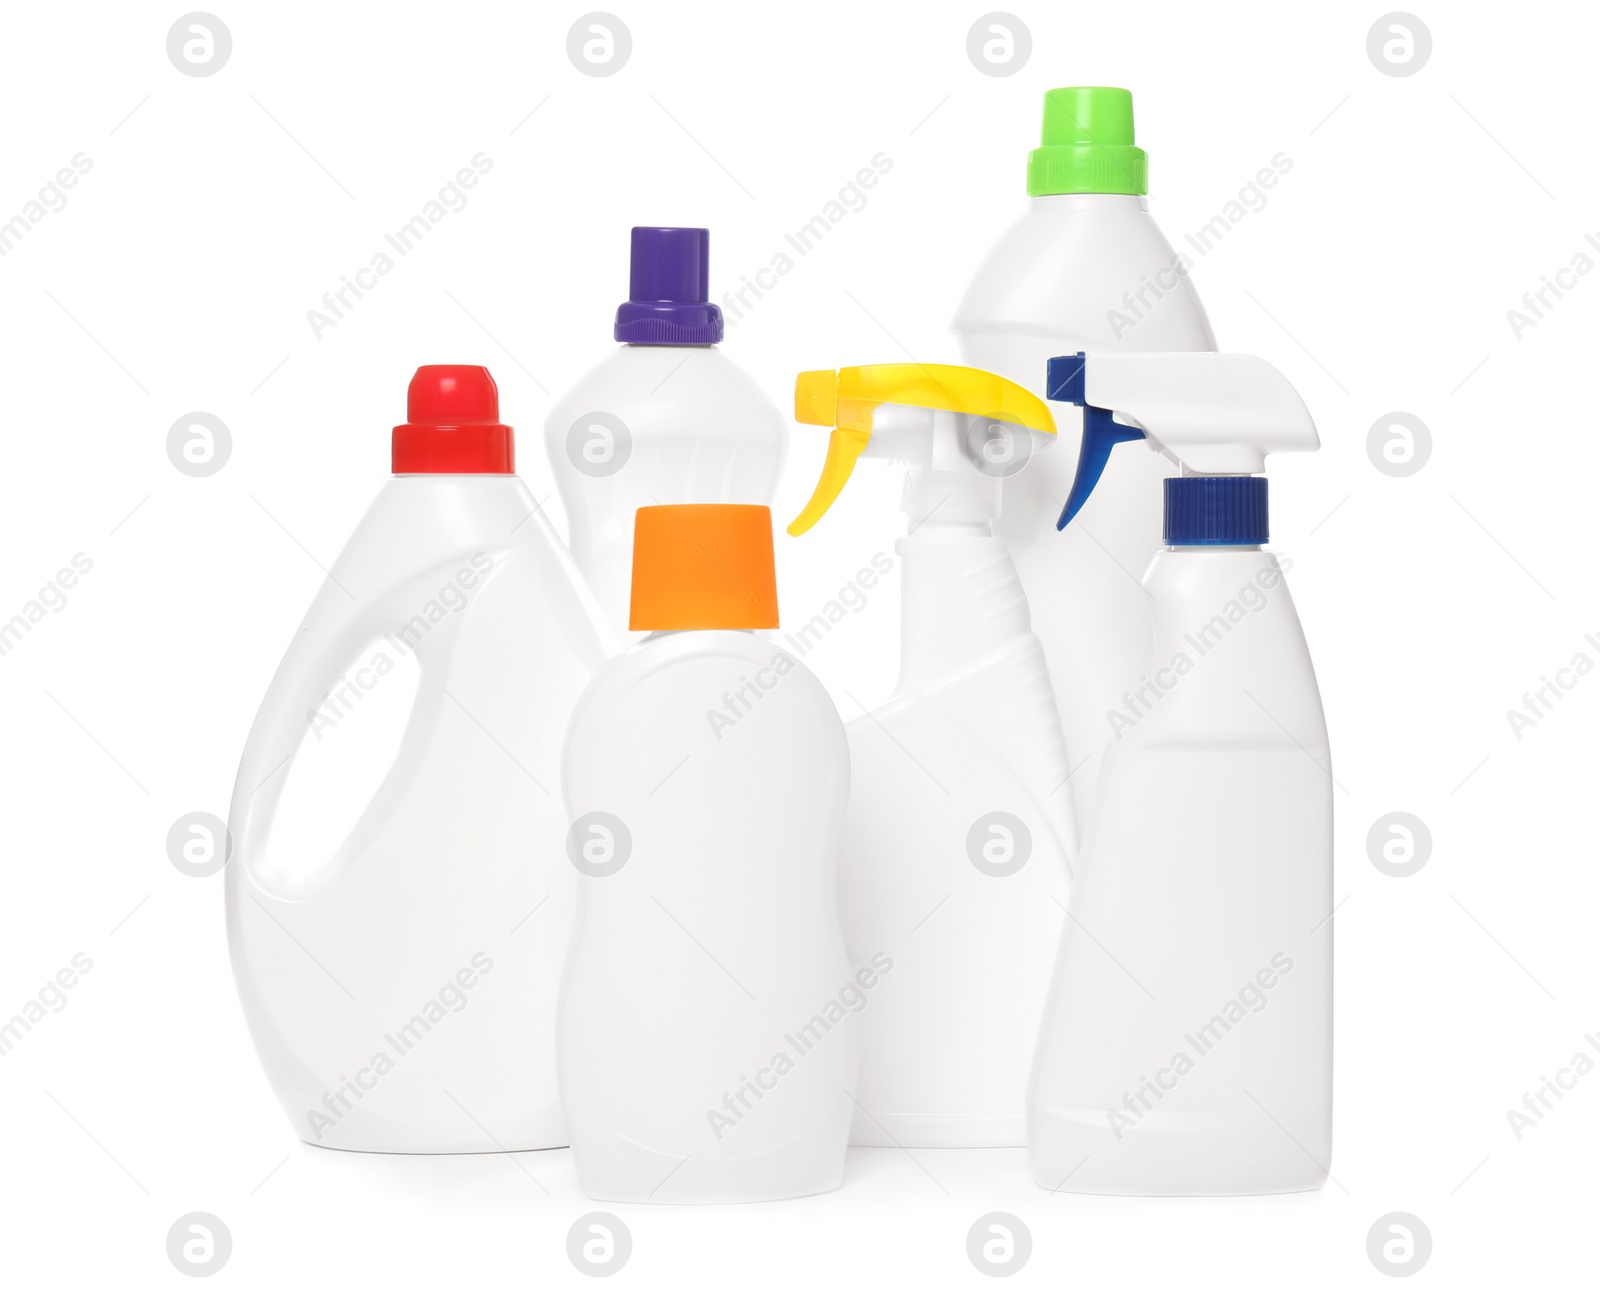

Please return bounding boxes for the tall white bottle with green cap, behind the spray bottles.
[955,88,1216,824]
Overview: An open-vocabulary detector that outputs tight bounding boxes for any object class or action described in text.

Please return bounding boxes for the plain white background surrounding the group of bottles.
[0,0,1600,1288]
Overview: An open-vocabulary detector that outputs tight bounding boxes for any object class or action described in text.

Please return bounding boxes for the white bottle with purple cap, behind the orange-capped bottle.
[544,227,789,645]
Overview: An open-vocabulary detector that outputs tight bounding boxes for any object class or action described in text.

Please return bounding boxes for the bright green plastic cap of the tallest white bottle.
[1027,85,1149,197]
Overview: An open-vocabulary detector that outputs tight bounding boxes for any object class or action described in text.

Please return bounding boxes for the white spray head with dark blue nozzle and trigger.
[1045,352,1318,530]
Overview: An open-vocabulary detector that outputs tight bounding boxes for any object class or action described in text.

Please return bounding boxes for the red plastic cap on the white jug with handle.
[394,363,515,475]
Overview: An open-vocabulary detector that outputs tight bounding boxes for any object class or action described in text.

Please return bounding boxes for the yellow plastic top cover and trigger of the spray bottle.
[789,363,1056,538]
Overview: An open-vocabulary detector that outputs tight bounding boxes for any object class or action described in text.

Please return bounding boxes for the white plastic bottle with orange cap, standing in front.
[560,506,857,1201]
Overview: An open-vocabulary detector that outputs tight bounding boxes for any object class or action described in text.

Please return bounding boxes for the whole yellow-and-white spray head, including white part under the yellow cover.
[789,363,1056,538]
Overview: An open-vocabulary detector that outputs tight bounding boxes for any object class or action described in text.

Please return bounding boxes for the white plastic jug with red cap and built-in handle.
[226,366,611,1152]
